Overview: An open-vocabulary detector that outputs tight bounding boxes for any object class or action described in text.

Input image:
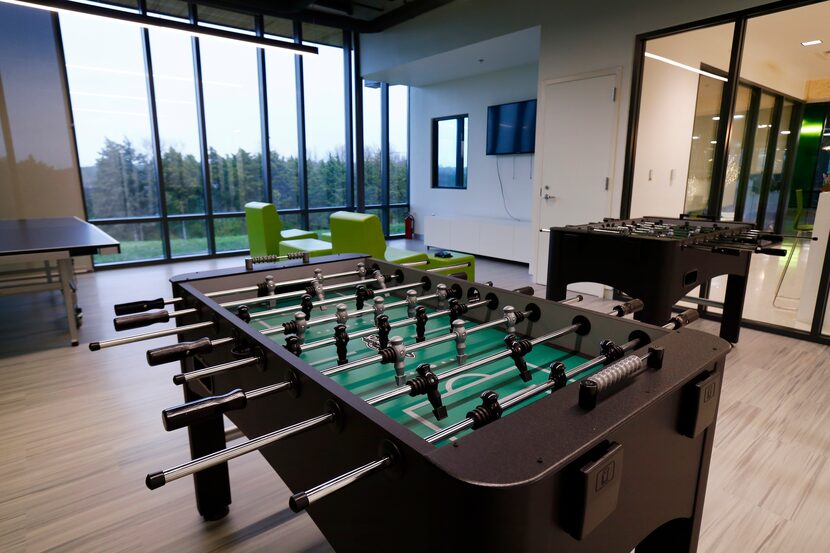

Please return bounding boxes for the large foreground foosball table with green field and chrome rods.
[90,255,730,553]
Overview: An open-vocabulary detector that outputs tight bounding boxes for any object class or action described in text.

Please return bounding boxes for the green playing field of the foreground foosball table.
[237,293,597,445]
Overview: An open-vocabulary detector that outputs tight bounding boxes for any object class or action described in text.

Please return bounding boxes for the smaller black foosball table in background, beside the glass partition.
[546,217,786,343]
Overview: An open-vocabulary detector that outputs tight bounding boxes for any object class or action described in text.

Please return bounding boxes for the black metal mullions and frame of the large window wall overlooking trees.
[47,0,409,268]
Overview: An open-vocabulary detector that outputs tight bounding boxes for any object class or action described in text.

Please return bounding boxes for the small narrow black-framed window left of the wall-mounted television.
[432,115,467,188]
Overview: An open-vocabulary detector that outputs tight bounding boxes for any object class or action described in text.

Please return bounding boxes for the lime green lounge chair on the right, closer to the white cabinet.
[329,211,428,263]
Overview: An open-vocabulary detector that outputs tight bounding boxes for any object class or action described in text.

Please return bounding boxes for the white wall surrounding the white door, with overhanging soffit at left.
[361,0,766,224]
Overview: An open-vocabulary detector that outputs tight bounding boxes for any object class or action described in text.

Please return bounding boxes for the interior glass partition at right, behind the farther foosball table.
[627,1,830,340]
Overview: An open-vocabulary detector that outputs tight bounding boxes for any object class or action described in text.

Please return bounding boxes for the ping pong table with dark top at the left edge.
[0,217,121,346]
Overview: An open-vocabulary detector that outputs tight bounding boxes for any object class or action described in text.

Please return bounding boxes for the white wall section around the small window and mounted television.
[409,65,538,225]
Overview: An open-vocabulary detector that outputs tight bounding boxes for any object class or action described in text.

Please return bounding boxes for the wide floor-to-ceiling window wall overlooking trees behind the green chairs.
[54,2,409,263]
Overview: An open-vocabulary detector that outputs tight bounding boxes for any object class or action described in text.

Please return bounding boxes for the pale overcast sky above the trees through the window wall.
[60,10,407,166]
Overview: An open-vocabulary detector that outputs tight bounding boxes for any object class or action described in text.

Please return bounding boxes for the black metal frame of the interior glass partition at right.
[620,0,830,345]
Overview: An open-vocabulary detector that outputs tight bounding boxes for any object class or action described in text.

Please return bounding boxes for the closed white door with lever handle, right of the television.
[534,73,618,288]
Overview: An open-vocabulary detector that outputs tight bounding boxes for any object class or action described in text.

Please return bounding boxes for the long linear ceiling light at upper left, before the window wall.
[0,0,317,55]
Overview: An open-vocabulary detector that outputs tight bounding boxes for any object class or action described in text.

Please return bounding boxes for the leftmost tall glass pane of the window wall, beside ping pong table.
[60,14,165,262]
